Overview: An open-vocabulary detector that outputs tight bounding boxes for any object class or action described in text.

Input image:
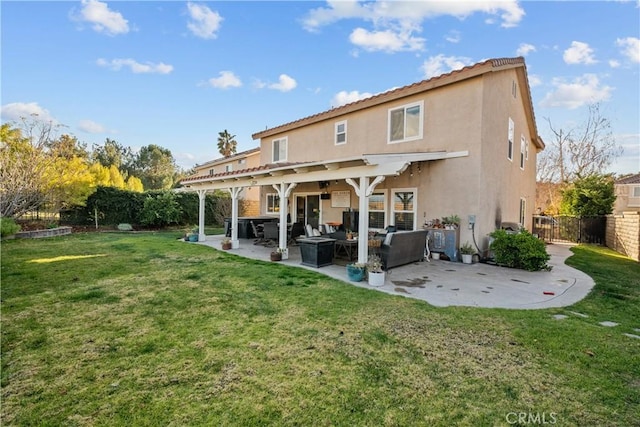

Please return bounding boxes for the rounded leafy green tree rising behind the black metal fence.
[560,174,616,216]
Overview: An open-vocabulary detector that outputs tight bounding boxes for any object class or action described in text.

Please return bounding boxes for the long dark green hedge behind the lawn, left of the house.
[60,187,231,227]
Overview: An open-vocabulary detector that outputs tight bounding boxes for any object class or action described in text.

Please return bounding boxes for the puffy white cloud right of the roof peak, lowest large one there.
[540,74,613,110]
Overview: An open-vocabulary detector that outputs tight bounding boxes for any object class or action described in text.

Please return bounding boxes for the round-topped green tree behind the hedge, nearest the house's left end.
[134,144,177,190]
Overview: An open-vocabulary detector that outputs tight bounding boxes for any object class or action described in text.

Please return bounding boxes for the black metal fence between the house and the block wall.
[533,215,607,245]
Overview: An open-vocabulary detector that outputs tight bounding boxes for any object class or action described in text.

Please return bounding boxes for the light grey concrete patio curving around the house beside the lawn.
[198,235,594,309]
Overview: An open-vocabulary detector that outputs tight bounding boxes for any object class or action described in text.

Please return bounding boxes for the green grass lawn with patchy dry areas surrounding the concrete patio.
[0,232,640,426]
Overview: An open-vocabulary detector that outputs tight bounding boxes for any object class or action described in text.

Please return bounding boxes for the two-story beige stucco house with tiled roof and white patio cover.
[182,58,544,262]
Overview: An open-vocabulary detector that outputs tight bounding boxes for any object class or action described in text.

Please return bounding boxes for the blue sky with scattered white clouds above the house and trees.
[0,0,640,173]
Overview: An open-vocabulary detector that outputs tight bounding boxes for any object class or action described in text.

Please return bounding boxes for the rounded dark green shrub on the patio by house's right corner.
[491,230,551,271]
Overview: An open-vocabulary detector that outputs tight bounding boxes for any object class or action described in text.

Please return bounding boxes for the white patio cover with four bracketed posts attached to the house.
[182,151,469,263]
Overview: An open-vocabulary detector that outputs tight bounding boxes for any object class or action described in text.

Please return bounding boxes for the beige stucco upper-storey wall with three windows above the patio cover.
[261,78,482,163]
